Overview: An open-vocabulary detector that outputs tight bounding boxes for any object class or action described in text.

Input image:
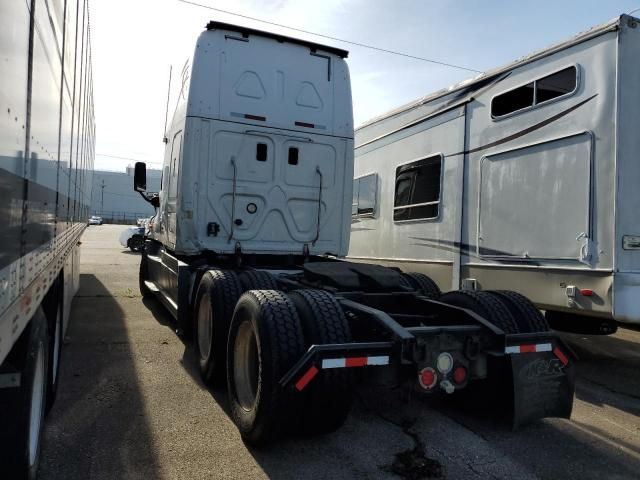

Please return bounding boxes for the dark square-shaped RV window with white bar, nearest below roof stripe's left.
[393,155,442,221]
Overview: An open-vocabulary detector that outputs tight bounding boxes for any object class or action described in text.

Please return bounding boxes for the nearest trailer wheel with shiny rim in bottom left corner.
[0,307,49,480]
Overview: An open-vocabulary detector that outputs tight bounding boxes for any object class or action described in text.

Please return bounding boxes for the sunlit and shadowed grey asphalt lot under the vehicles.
[40,225,640,480]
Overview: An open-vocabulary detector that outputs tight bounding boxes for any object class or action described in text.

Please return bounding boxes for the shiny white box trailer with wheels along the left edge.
[0,0,94,479]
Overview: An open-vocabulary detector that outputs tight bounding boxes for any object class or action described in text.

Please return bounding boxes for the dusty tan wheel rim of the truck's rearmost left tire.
[233,320,260,411]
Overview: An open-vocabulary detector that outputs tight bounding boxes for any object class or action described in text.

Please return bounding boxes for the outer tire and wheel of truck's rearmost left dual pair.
[227,290,304,446]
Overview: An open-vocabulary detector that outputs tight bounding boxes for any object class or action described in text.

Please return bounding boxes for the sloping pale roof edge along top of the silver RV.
[355,14,640,132]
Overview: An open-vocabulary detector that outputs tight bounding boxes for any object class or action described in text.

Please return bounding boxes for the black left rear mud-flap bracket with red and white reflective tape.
[279,342,394,391]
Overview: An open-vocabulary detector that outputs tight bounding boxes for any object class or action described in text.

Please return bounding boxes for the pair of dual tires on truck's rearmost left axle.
[227,290,354,445]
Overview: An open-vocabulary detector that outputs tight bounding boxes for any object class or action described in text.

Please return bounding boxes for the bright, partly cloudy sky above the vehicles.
[91,0,640,171]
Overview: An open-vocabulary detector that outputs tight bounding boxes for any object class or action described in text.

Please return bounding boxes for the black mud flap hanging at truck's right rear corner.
[509,347,575,430]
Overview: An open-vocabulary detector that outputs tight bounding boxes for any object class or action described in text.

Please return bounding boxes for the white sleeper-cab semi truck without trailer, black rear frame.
[134,22,573,444]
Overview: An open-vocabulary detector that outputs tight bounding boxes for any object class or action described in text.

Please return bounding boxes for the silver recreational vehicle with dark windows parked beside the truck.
[349,15,640,333]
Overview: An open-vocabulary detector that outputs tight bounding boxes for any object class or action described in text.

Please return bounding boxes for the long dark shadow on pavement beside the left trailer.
[39,274,160,480]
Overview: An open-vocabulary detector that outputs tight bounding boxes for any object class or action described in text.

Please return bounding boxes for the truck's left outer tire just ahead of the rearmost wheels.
[193,270,241,386]
